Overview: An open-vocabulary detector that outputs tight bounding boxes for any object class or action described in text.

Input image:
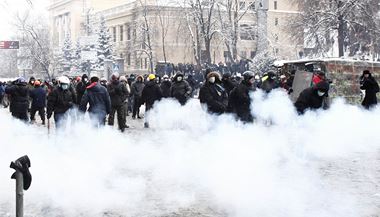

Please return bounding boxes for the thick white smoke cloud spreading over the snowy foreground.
[0,91,380,217]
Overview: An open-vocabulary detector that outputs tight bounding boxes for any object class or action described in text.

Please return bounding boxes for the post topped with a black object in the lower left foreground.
[10,155,32,217]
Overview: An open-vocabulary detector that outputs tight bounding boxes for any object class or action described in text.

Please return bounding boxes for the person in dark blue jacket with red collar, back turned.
[79,74,111,127]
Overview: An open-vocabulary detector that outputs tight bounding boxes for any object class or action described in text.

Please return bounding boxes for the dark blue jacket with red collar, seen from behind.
[79,83,111,114]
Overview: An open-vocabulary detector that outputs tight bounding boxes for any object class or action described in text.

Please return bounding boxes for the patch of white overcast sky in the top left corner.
[0,0,49,40]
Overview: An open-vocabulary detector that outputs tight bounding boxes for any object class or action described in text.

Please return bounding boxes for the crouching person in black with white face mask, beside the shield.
[294,81,330,114]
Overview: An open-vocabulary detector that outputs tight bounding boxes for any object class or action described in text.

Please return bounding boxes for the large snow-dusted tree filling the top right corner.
[291,0,379,56]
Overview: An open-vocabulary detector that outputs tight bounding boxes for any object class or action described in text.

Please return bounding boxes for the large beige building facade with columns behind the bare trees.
[49,0,303,73]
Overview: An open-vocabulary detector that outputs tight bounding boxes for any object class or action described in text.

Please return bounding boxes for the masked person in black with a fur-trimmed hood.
[199,72,228,114]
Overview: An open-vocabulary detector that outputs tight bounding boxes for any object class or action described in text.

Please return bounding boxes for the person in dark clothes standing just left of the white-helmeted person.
[30,81,46,125]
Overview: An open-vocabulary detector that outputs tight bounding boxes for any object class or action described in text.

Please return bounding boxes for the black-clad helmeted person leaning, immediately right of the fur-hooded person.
[228,71,256,123]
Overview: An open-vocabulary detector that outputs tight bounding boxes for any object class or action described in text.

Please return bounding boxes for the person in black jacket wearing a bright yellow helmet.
[141,74,162,128]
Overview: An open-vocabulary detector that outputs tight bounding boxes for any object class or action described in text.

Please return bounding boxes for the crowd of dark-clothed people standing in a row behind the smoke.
[0,69,379,132]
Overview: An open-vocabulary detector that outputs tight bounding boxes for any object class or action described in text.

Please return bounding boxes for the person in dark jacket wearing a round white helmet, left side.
[47,76,77,129]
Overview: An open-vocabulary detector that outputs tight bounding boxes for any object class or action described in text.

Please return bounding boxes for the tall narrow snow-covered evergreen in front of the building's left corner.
[97,16,113,69]
